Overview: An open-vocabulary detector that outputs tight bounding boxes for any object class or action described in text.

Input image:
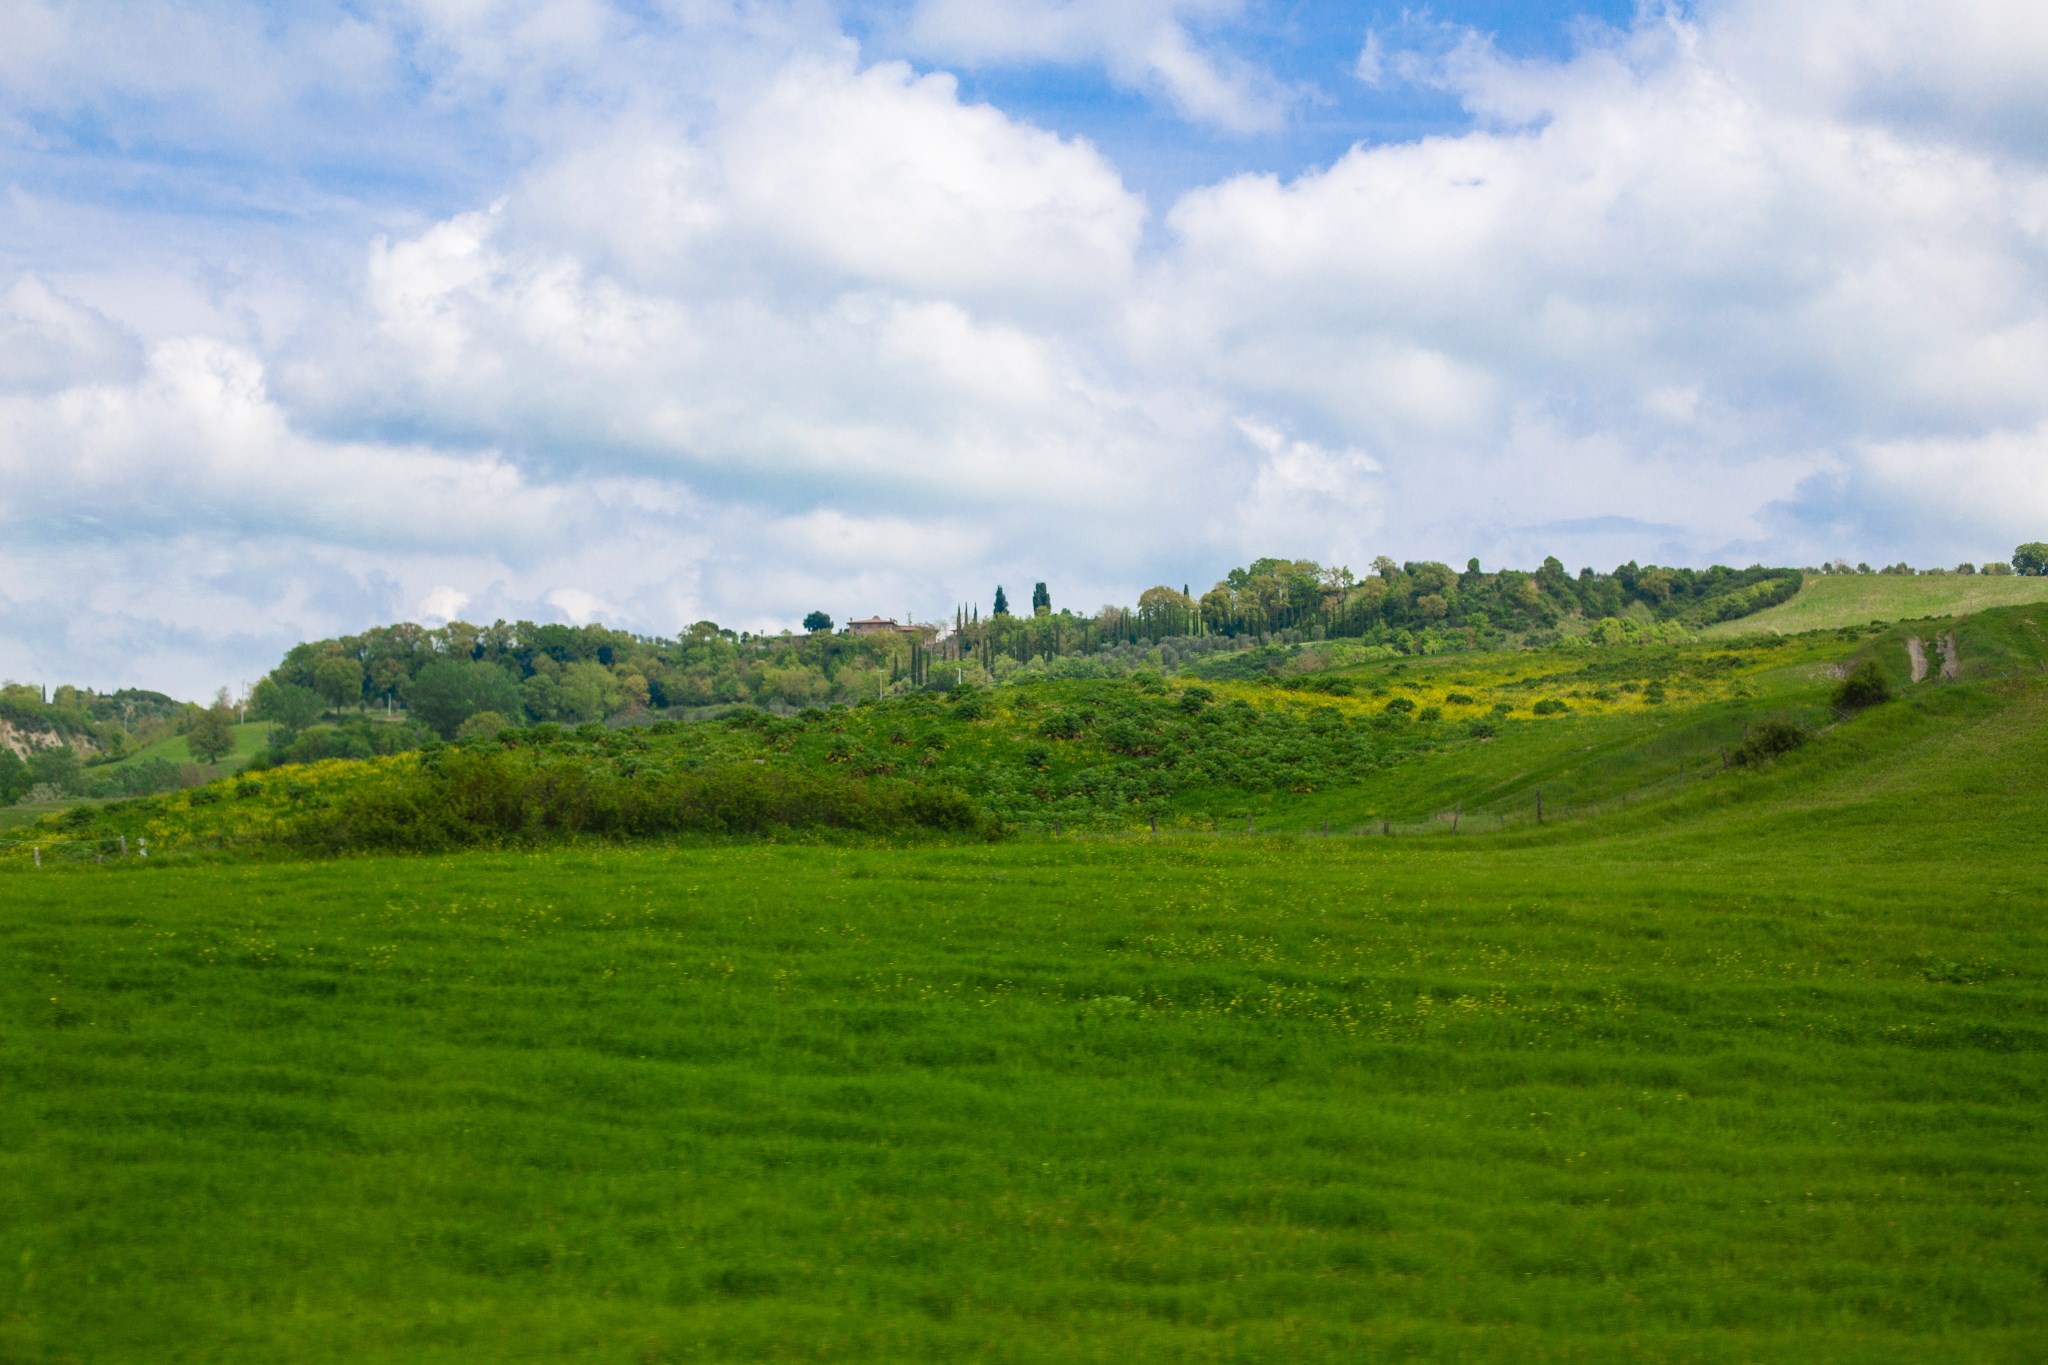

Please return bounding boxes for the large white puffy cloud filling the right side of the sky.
[1145,6,2048,555]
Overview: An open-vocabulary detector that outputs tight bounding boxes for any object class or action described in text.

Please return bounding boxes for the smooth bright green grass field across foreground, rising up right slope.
[0,614,2048,1365]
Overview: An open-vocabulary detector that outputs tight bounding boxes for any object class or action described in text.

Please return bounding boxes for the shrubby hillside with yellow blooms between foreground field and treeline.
[16,608,2048,851]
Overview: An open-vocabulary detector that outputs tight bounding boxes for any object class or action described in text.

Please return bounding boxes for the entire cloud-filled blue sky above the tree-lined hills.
[0,0,2048,694]
